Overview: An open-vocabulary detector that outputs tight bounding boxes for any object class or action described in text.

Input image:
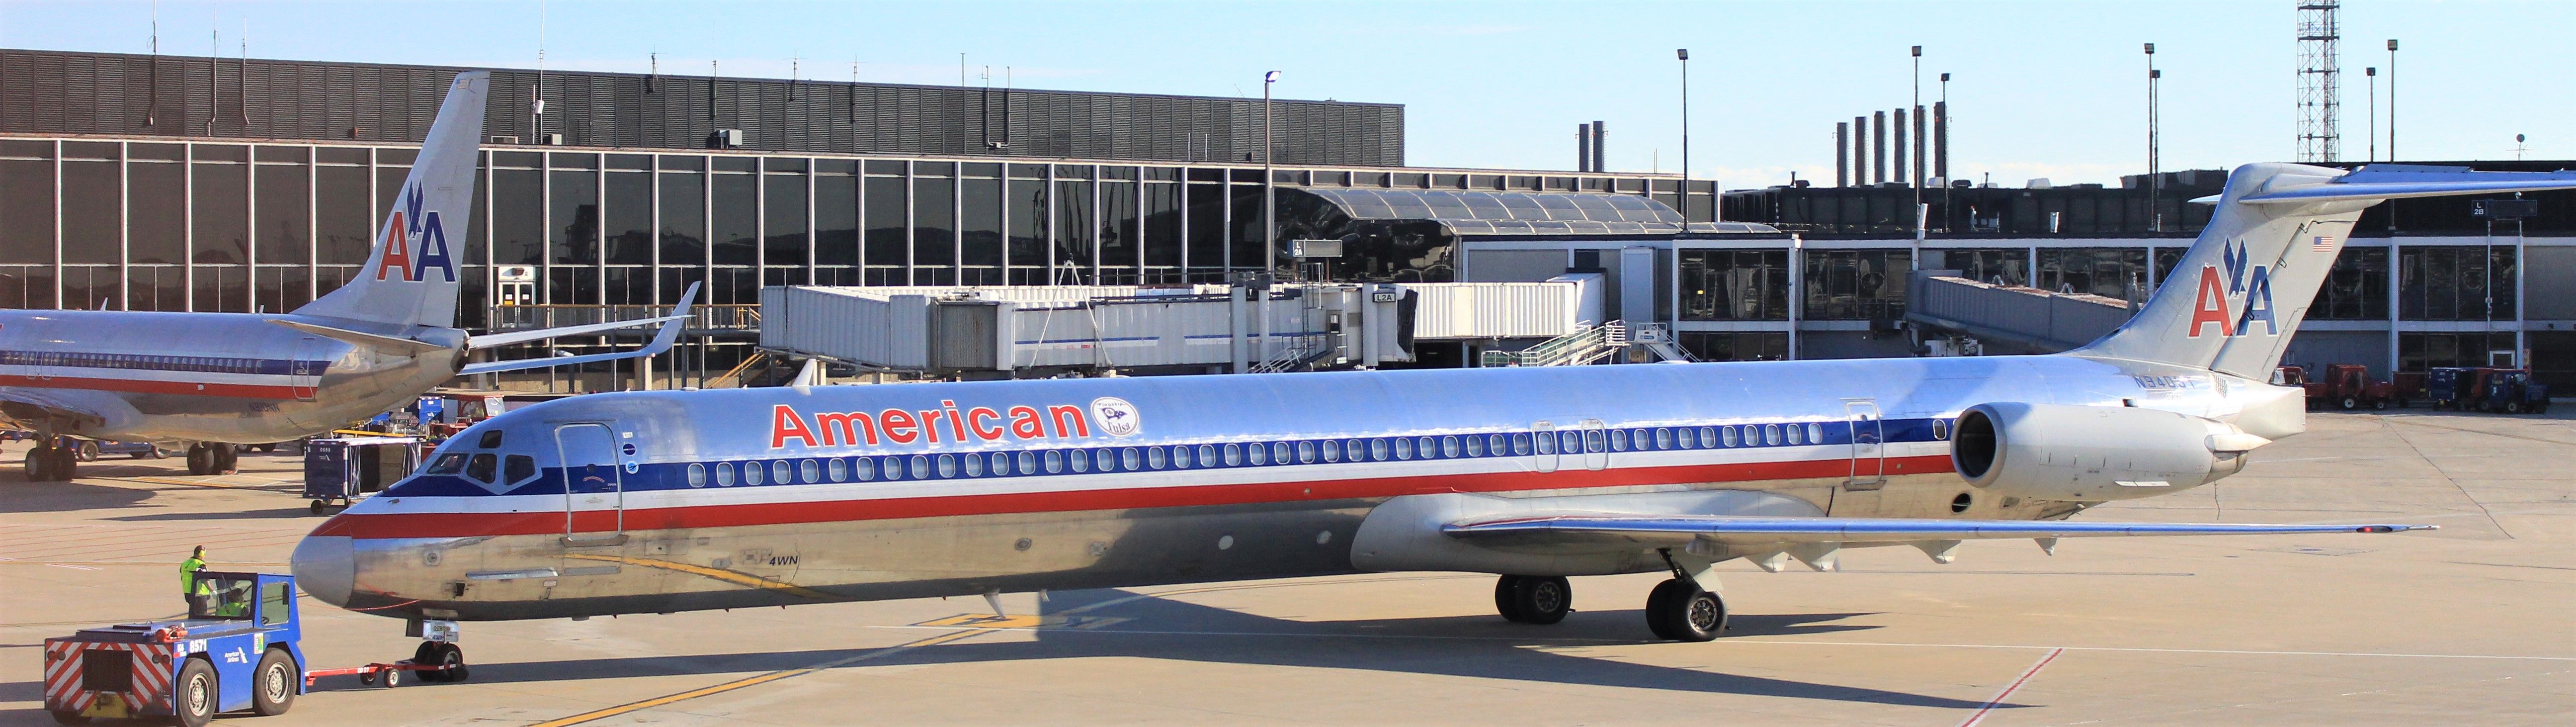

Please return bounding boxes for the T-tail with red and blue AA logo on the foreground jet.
[2069,163,2576,381]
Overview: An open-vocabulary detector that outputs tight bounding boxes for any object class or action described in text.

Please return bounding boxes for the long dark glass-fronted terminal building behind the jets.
[0,49,2576,389]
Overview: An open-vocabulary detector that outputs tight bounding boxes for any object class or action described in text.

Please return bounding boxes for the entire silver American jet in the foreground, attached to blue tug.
[294,153,2576,665]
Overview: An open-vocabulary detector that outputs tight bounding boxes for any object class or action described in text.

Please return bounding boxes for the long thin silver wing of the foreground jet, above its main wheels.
[1440,516,2439,546]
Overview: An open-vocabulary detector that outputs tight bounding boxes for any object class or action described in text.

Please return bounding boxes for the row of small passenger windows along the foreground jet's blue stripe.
[688,423,1824,487]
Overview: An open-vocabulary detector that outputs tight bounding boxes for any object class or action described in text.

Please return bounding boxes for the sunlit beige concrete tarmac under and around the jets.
[0,410,2576,727]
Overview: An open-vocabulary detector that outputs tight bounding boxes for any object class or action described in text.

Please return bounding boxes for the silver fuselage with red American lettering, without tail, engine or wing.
[296,356,2298,619]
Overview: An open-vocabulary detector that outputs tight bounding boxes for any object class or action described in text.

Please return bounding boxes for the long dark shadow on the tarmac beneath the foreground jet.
[448,590,2017,709]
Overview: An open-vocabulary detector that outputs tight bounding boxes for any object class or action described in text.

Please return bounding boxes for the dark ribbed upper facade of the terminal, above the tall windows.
[0,49,1404,168]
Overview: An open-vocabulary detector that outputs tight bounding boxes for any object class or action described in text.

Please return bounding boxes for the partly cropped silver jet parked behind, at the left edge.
[0,72,695,482]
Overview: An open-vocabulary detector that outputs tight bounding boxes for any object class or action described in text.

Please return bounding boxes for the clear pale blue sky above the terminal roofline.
[0,0,2576,188]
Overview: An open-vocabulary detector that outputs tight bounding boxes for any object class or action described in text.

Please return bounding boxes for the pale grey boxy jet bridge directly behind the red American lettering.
[760,283,1414,379]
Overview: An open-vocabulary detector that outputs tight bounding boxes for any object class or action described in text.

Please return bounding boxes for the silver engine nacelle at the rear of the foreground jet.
[1950,402,2272,503]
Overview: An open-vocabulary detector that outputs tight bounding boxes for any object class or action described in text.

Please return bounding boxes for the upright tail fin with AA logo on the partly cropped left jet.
[296,72,492,327]
